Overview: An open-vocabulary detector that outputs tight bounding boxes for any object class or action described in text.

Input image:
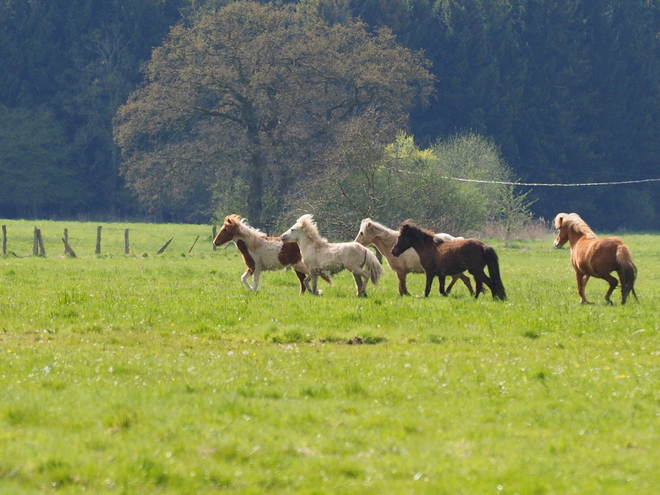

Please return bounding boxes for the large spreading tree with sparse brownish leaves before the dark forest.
[115,1,432,226]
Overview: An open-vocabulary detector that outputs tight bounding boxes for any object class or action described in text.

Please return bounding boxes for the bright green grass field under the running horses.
[0,221,660,495]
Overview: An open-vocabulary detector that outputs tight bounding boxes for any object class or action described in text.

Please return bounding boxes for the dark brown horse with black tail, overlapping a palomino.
[392,220,506,300]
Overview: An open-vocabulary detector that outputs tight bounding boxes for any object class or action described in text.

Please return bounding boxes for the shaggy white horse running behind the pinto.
[281,214,383,297]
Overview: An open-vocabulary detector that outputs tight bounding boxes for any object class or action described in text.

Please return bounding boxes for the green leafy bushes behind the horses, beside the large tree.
[288,132,530,239]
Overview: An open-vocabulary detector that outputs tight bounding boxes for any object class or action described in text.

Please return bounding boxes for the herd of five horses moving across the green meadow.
[213,213,637,304]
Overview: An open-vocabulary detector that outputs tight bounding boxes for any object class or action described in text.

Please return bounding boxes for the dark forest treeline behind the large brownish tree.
[0,0,660,229]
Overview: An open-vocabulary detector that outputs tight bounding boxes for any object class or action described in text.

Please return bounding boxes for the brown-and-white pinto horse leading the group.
[213,215,330,294]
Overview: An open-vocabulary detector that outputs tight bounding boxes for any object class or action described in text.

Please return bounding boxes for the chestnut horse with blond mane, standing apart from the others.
[554,213,637,304]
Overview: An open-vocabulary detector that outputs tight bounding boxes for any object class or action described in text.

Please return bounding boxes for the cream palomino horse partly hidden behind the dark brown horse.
[355,218,474,296]
